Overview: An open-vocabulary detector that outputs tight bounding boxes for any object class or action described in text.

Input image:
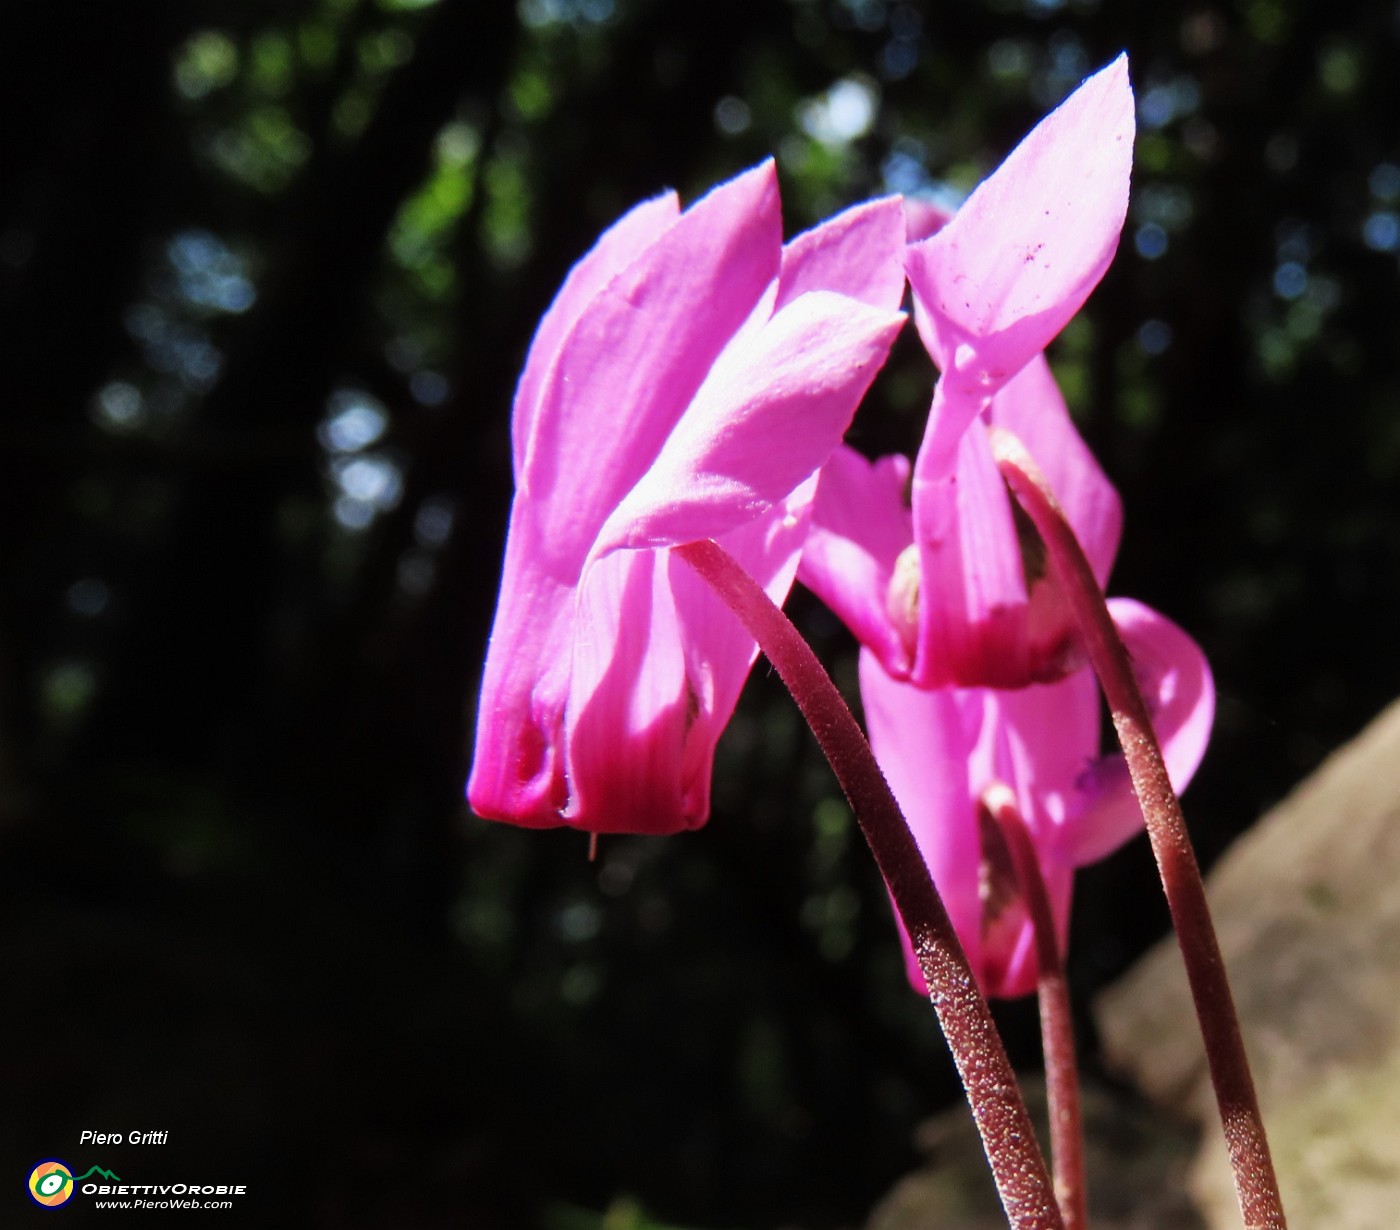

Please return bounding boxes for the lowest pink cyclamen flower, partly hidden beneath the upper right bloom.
[861,599,1215,998]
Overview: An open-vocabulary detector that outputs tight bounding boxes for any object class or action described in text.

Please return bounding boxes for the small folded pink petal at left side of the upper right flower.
[797,445,913,679]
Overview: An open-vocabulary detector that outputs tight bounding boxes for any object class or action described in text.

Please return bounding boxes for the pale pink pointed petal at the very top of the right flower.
[906,56,1134,396]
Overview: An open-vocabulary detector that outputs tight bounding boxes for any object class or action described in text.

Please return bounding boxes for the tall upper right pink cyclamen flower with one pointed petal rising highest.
[801,57,1134,687]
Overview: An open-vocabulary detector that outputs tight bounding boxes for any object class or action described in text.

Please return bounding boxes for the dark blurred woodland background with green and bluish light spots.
[0,0,1400,1230]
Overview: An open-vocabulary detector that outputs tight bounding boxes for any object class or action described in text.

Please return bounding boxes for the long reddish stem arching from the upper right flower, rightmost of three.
[988,427,1287,1230]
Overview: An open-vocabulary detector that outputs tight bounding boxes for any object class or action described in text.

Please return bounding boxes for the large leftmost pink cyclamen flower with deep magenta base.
[468,161,904,833]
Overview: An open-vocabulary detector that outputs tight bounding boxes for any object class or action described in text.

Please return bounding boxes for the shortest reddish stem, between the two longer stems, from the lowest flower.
[979,786,1089,1230]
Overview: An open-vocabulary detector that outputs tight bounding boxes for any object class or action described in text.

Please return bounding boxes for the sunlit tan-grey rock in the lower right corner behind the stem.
[1098,702,1400,1230]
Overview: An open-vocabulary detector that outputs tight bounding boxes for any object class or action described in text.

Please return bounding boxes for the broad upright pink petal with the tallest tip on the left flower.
[518,162,783,568]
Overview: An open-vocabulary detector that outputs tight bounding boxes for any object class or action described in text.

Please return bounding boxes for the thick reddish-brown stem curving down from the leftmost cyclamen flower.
[673,540,1064,1230]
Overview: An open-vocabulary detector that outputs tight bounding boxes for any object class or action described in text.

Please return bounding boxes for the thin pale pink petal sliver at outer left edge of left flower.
[511,192,680,483]
